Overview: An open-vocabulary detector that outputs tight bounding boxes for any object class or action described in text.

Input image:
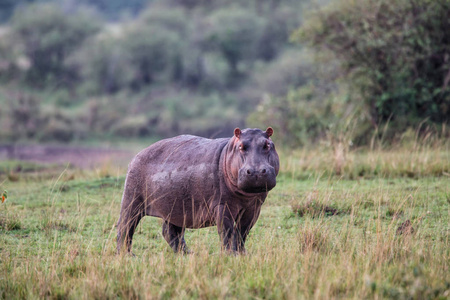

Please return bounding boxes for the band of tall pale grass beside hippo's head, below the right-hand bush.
[281,132,450,179]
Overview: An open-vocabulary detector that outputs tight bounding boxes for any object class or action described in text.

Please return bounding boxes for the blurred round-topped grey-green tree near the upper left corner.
[12,3,100,85]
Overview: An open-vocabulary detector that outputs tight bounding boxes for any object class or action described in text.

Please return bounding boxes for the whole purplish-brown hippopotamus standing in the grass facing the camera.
[117,127,279,254]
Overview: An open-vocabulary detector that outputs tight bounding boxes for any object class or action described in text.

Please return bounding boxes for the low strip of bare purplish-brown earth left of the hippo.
[0,145,133,169]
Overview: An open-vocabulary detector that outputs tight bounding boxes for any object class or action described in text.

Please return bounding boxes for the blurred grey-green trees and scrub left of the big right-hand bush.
[0,0,302,141]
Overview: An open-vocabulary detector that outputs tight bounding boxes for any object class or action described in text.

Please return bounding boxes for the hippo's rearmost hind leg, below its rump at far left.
[117,196,145,254]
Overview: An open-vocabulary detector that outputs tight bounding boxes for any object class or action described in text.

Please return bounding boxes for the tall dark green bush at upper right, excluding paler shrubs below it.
[293,0,450,136]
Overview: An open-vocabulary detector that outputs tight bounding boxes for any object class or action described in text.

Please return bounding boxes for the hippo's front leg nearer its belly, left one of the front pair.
[216,204,237,252]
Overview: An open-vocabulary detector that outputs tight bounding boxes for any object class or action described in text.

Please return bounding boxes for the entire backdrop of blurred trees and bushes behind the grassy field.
[0,0,450,146]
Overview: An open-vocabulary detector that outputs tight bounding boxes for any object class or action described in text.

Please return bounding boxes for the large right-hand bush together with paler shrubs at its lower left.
[251,0,450,145]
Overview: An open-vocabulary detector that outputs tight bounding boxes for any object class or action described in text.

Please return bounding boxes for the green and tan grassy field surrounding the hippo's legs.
[0,144,450,299]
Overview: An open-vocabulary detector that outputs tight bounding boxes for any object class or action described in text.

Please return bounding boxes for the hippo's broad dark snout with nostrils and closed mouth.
[238,165,276,193]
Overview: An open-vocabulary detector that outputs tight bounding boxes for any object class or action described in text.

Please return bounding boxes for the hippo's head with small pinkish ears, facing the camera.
[227,127,280,194]
